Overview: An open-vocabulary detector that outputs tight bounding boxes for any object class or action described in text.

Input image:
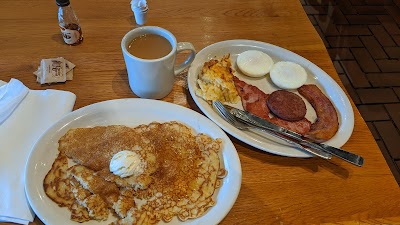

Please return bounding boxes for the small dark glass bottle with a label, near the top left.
[56,0,83,45]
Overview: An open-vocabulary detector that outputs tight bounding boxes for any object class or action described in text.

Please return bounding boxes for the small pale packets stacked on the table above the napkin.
[33,57,75,84]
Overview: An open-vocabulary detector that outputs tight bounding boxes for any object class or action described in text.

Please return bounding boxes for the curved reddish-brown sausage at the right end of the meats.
[298,85,339,142]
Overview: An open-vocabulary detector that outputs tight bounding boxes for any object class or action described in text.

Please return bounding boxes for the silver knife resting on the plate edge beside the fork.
[226,106,364,166]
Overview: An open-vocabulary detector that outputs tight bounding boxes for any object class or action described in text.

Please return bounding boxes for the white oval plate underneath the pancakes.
[25,99,242,225]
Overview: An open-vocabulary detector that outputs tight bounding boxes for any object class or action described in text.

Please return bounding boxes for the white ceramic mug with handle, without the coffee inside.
[121,26,196,99]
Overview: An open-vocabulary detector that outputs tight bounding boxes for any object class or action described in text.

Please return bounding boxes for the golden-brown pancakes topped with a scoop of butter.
[43,121,226,224]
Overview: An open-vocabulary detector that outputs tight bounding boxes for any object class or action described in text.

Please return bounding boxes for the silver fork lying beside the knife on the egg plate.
[213,101,332,159]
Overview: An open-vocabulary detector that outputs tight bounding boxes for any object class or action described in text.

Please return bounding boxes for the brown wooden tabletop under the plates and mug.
[0,0,400,224]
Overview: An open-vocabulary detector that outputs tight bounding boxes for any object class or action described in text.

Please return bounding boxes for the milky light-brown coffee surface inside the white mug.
[128,34,172,59]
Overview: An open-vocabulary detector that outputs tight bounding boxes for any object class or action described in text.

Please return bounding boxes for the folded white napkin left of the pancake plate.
[0,79,76,224]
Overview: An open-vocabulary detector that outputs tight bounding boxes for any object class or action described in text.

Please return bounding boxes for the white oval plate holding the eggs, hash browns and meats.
[188,40,354,158]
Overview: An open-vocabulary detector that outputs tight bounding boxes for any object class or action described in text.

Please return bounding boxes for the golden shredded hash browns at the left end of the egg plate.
[196,54,240,103]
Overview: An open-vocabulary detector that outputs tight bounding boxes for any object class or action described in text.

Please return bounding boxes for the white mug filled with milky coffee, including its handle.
[121,26,196,99]
